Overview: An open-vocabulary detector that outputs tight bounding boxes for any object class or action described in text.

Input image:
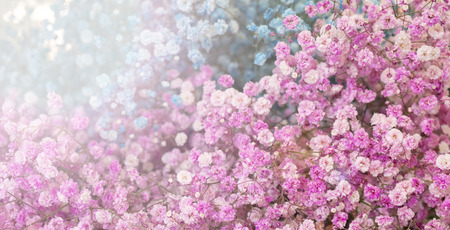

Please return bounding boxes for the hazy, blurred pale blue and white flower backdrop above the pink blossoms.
[0,0,313,109]
